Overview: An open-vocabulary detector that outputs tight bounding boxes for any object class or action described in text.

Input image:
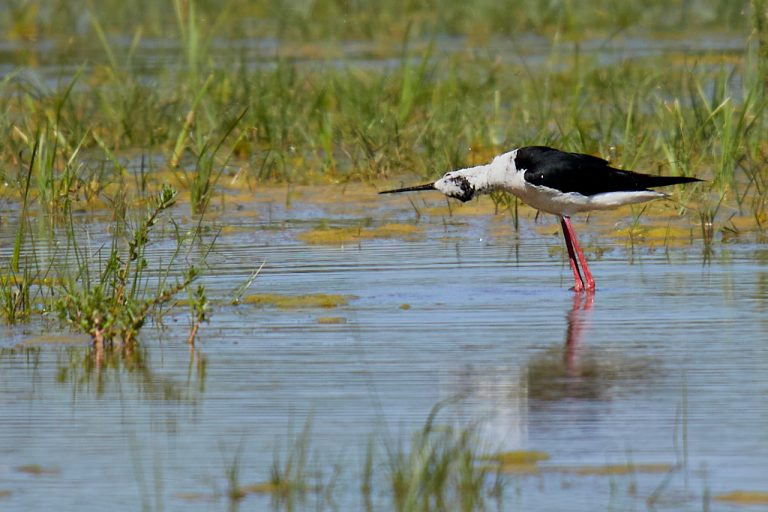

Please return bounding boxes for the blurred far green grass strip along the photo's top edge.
[0,0,744,44]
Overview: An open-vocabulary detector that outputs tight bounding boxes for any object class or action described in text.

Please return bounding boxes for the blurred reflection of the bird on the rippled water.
[442,294,660,450]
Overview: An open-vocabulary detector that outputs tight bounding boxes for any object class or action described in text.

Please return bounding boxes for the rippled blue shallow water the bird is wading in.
[0,193,768,511]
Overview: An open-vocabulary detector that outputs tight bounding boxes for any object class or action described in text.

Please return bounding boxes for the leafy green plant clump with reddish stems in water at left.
[56,186,204,349]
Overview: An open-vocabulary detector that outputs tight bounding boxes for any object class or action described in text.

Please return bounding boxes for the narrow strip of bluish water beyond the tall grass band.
[0,32,746,90]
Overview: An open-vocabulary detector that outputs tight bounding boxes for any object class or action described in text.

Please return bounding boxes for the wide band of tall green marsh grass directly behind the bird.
[0,8,768,236]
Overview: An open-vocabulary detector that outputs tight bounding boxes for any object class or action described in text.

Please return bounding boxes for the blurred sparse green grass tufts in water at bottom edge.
[214,405,504,511]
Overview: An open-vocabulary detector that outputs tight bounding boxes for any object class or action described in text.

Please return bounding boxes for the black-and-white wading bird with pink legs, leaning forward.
[379,146,701,292]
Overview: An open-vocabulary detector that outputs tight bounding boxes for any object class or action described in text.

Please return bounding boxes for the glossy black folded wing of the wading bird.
[515,146,701,196]
